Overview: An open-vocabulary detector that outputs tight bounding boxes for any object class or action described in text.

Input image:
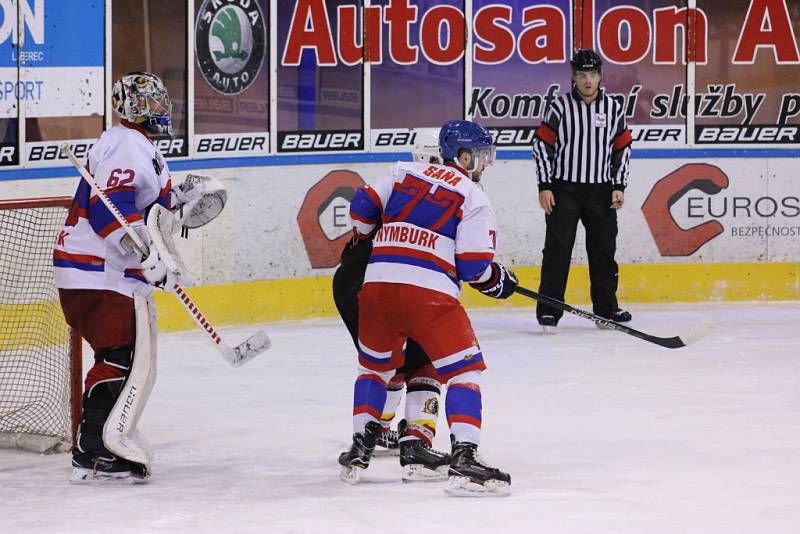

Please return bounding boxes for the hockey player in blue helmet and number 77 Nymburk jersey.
[339,120,517,495]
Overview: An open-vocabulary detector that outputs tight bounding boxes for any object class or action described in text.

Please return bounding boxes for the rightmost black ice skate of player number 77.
[444,442,511,497]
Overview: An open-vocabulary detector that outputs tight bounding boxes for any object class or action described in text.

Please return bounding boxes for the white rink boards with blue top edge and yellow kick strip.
[0,150,800,330]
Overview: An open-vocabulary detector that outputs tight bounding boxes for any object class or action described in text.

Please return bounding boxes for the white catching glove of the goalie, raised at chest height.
[172,174,228,232]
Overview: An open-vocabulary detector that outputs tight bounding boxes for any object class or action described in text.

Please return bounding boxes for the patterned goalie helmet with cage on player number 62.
[111,72,172,135]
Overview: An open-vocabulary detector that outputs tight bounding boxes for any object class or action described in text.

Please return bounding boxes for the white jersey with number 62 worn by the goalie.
[53,124,172,296]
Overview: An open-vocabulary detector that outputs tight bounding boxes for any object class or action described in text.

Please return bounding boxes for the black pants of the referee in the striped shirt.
[536,181,619,320]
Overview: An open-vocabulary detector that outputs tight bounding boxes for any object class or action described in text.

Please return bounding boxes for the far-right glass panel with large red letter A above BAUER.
[695,0,800,145]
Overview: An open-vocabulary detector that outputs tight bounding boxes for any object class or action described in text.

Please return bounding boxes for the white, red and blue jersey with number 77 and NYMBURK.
[350,163,497,298]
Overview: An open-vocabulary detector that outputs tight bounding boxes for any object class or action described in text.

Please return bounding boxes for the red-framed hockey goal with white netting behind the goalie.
[0,197,83,452]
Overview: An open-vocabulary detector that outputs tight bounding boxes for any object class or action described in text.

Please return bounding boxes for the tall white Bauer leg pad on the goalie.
[103,294,156,478]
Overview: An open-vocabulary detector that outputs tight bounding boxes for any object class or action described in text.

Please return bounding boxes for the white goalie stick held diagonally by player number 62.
[61,143,271,367]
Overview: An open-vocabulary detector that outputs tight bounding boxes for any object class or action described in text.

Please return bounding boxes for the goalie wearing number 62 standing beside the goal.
[53,72,221,484]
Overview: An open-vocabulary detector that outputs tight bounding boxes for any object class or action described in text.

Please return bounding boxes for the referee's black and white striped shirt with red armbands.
[533,86,632,195]
